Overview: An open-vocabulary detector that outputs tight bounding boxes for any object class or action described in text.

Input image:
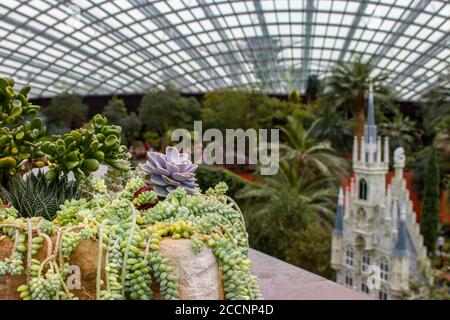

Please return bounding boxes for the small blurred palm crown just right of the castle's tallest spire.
[380,114,422,151]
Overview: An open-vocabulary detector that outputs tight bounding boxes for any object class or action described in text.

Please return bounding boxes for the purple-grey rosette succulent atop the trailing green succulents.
[142,147,197,197]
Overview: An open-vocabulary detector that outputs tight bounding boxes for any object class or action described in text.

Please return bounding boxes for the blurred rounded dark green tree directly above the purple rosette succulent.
[139,87,201,135]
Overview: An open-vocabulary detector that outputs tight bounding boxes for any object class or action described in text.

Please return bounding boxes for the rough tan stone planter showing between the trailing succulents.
[0,238,224,300]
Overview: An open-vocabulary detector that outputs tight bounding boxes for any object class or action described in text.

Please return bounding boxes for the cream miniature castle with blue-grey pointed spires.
[331,84,431,299]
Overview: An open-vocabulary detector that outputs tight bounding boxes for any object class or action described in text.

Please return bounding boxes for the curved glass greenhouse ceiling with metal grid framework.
[0,0,450,100]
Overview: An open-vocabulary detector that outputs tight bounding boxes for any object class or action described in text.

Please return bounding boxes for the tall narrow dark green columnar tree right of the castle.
[420,148,440,256]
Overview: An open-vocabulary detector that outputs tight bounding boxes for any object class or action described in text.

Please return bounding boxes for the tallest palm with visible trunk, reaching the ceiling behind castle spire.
[325,57,392,137]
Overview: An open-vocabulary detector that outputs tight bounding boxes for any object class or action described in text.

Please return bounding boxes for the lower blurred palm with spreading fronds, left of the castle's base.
[237,159,337,233]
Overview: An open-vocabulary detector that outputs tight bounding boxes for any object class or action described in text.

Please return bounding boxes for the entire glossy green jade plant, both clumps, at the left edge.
[0,78,131,185]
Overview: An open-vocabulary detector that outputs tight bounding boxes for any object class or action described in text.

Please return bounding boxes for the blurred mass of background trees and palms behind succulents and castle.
[36,57,450,278]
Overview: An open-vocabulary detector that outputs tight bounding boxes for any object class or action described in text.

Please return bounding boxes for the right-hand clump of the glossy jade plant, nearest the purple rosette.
[42,114,130,181]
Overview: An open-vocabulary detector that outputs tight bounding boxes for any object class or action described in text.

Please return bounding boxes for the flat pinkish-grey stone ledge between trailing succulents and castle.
[249,249,372,300]
